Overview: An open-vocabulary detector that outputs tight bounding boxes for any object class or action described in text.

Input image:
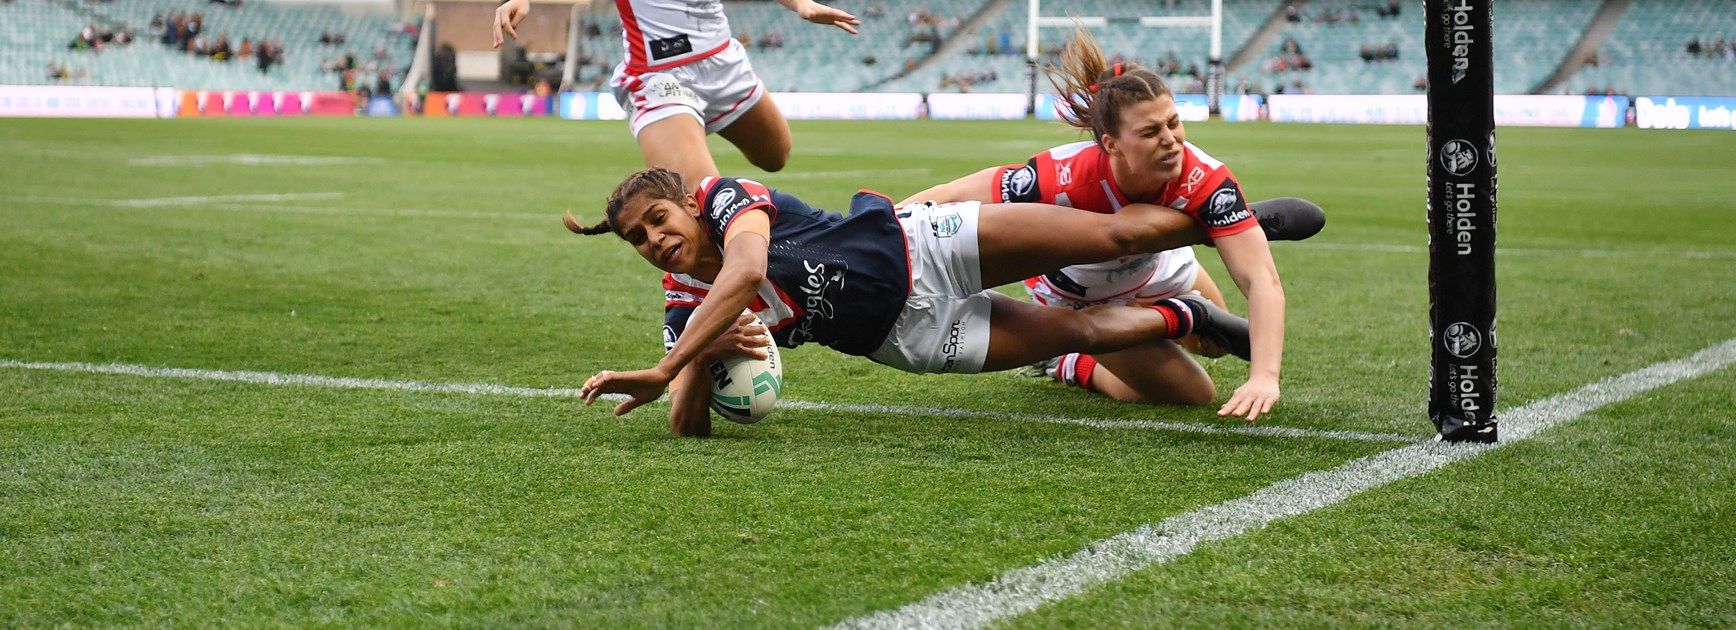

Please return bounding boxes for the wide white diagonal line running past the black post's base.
[835,338,1736,628]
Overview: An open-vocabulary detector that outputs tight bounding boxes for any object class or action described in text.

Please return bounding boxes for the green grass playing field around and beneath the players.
[0,118,1736,628]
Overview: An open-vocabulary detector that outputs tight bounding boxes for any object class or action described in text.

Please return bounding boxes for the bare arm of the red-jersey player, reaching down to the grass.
[1215,229,1285,422]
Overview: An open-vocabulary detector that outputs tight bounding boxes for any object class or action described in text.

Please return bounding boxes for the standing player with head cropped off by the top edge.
[495,0,861,182]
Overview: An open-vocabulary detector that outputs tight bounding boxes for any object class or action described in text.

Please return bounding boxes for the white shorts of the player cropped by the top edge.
[609,40,766,137]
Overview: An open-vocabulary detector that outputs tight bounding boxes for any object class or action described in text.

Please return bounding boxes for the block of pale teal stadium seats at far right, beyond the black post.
[1564,0,1736,95]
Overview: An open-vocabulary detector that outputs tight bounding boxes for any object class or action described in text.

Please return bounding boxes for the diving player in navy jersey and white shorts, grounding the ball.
[568,168,1248,442]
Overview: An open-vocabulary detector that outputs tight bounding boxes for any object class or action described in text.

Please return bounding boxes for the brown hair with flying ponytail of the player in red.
[1043,26,1172,144]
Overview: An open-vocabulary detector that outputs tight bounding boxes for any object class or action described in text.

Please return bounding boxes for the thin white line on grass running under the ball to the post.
[0,359,1418,443]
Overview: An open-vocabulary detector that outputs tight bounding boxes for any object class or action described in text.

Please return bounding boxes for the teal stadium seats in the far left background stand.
[0,0,415,90]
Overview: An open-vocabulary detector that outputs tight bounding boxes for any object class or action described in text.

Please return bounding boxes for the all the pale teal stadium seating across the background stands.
[13,0,1736,95]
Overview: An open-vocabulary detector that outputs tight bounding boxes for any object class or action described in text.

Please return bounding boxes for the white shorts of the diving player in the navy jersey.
[868,201,990,373]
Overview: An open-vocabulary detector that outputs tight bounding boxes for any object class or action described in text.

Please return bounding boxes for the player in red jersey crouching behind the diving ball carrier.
[904,30,1325,420]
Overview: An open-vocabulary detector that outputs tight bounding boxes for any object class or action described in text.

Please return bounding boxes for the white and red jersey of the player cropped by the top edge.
[615,0,729,75]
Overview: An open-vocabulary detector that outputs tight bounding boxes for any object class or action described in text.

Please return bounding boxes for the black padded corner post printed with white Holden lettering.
[1424,0,1496,443]
